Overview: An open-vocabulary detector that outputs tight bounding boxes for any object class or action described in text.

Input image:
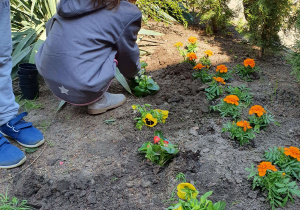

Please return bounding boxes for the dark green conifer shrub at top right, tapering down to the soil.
[243,0,292,54]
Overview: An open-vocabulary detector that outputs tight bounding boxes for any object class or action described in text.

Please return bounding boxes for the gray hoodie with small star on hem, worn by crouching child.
[35,0,142,105]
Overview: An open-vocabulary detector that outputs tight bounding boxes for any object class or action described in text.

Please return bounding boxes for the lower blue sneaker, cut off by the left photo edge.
[0,133,26,168]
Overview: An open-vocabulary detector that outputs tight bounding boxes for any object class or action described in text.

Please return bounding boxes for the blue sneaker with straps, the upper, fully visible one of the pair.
[0,112,45,147]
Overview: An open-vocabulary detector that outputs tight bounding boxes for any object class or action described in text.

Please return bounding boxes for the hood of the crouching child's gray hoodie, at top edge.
[57,0,106,18]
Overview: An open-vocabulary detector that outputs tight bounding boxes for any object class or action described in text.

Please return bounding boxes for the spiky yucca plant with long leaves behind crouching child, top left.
[11,0,57,78]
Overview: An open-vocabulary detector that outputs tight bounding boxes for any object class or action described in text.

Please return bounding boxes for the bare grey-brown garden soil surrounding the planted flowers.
[0,22,300,210]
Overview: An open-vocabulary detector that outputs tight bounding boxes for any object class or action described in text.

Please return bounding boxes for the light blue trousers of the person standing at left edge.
[0,0,19,126]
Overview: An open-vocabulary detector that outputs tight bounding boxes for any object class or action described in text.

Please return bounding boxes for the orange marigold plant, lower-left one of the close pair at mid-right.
[222,121,255,145]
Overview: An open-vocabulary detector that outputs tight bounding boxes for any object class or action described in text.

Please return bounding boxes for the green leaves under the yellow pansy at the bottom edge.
[167,191,226,210]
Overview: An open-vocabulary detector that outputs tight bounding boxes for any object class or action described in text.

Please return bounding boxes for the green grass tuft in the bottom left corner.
[0,189,32,210]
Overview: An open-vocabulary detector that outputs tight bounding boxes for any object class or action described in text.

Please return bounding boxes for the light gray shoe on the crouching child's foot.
[88,92,126,114]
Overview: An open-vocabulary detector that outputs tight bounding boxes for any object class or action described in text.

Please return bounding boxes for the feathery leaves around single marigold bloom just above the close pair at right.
[226,85,253,108]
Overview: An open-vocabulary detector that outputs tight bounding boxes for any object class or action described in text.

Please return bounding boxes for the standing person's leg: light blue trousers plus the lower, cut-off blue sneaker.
[0,0,26,168]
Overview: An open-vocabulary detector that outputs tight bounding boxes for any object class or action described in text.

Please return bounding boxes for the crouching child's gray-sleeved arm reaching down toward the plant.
[116,13,142,79]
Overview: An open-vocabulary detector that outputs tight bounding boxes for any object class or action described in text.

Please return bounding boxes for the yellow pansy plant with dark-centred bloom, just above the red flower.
[131,104,169,130]
